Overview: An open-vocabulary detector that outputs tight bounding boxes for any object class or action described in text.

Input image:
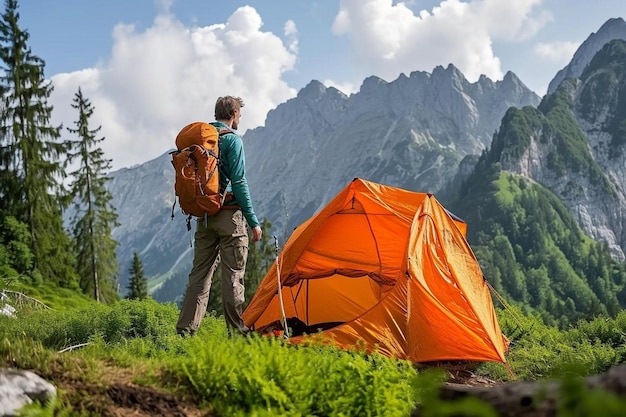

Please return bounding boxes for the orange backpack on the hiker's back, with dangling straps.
[170,122,231,227]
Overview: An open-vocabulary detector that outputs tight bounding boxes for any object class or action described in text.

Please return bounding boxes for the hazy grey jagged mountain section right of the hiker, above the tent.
[244,65,539,240]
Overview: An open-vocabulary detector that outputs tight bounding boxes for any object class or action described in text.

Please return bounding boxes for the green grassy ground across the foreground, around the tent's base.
[0,288,626,416]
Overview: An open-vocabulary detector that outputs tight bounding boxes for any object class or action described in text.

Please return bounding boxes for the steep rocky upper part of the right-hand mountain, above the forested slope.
[493,39,626,261]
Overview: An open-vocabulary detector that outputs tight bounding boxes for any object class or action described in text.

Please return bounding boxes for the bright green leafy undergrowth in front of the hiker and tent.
[168,337,416,416]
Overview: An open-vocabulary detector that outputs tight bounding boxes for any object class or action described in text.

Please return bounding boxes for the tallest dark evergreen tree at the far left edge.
[0,0,78,288]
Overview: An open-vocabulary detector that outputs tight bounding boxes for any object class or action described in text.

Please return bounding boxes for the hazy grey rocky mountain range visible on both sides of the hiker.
[110,65,539,292]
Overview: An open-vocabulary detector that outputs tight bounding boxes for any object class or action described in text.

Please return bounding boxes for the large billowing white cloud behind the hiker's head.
[51,6,297,169]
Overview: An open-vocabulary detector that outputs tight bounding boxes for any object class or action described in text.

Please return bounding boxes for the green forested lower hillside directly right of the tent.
[450,164,626,328]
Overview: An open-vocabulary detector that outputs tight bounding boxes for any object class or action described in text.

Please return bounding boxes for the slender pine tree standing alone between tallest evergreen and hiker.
[67,88,119,302]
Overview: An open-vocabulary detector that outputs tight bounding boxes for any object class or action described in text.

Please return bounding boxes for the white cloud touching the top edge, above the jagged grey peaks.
[332,0,550,85]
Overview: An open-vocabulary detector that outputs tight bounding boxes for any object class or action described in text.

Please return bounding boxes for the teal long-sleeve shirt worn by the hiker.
[211,122,259,228]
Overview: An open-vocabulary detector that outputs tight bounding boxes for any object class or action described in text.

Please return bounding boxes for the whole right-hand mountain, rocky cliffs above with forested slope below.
[448,39,626,327]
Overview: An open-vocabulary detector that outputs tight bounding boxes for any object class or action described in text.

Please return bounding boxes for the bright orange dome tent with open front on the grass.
[243,179,508,363]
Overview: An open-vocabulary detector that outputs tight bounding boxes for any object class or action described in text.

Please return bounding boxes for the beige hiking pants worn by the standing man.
[176,209,249,334]
